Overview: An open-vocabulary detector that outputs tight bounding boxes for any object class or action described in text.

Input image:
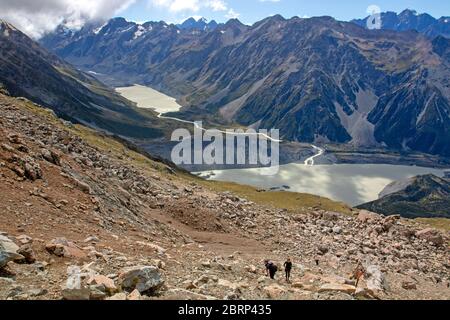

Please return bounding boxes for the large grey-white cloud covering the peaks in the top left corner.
[0,0,136,38]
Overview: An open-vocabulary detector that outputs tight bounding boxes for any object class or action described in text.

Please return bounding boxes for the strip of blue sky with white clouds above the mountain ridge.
[117,0,450,24]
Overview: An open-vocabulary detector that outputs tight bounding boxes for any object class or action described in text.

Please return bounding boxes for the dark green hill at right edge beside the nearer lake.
[359,175,450,218]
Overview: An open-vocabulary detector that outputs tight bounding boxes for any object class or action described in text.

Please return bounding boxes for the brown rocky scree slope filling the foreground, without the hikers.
[0,95,450,300]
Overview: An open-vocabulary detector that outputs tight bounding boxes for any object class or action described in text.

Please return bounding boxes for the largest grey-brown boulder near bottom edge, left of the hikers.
[118,266,164,295]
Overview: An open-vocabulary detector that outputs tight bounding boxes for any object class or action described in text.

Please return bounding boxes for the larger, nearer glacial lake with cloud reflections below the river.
[197,163,445,206]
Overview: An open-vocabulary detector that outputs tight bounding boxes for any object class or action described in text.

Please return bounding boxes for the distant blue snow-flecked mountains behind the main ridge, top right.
[352,10,450,38]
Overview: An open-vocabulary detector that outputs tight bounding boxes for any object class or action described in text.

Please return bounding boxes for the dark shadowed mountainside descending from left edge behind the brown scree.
[0,21,161,138]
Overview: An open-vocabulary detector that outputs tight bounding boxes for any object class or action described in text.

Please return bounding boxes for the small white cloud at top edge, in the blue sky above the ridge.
[149,0,228,13]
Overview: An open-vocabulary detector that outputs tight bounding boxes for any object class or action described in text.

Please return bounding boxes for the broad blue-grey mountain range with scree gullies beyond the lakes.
[43,16,450,156]
